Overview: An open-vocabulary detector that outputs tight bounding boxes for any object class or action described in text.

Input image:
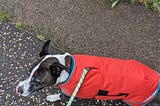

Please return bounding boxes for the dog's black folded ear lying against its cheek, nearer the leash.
[49,62,68,76]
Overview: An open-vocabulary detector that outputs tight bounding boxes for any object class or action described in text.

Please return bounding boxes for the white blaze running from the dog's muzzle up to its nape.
[17,53,69,96]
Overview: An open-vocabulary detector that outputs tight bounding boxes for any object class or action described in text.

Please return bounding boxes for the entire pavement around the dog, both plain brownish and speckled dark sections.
[0,0,160,106]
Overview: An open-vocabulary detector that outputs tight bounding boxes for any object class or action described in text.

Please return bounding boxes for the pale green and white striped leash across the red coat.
[67,68,90,106]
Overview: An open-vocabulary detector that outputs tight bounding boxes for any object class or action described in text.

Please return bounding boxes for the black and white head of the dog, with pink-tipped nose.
[16,40,70,96]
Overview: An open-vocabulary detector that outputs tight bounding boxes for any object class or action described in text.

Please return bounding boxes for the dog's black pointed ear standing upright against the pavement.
[39,40,51,57]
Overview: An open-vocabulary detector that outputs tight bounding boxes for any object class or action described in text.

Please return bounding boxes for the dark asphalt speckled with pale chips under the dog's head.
[0,21,158,106]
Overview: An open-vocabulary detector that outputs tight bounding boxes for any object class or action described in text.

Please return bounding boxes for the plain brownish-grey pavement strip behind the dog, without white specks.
[0,0,160,58]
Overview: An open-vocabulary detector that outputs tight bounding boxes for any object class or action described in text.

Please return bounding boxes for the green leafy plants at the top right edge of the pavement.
[110,0,160,12]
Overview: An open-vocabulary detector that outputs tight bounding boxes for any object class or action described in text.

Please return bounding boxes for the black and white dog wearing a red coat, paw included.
[16,40,160,106]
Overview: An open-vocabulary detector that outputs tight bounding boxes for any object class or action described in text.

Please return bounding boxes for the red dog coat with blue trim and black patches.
[59,55,159,106]
